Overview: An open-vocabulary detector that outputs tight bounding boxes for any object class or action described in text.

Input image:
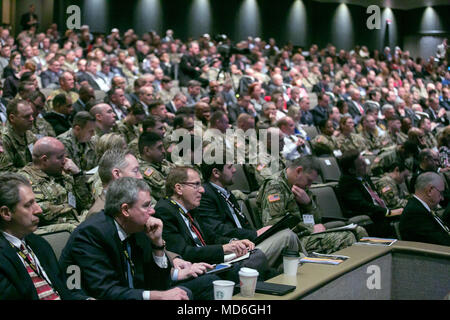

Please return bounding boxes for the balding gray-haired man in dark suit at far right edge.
[399,172,450,246]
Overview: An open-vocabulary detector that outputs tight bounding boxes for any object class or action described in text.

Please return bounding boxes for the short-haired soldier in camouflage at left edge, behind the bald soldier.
[0,100,36,171]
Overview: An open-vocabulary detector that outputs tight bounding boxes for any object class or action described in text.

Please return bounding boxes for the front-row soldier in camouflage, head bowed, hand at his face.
[256,156,356,253]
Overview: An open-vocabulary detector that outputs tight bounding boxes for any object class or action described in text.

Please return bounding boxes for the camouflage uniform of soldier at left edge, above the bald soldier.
[0,123,37,172]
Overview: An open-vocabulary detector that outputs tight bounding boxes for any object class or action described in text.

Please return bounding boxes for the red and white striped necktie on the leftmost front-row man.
[19,244,61,300]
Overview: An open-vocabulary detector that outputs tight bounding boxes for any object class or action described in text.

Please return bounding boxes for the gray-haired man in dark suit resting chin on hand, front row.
[60,177,216,300]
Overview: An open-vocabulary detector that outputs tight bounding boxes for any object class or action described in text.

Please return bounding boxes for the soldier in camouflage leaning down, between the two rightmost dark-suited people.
[375,162,409,209]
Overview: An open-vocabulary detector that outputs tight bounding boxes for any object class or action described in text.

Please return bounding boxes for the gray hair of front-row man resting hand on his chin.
[105,177,150,217]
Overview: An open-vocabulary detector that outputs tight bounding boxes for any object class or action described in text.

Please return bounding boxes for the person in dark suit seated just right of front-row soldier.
[336,150,403,237]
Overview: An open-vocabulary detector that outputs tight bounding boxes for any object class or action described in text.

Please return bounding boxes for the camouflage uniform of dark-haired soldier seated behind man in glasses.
[138,157,174,201]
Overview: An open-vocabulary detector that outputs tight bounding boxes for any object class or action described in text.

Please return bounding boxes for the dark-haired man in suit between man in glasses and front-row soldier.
[192,161,299,268]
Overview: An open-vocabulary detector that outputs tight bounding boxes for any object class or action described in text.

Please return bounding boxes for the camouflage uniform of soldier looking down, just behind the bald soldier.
[58,128,97,170]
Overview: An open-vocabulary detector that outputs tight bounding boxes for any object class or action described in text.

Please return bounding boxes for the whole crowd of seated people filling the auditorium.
[0,25,450,300]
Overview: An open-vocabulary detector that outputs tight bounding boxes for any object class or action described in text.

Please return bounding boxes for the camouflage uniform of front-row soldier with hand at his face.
[256,170,356,253]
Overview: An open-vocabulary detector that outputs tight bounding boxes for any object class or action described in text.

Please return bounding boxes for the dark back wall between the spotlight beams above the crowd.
[55,0,450,49]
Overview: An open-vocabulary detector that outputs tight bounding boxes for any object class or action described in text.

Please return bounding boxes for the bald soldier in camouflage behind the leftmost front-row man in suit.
[19,137,92,233]
